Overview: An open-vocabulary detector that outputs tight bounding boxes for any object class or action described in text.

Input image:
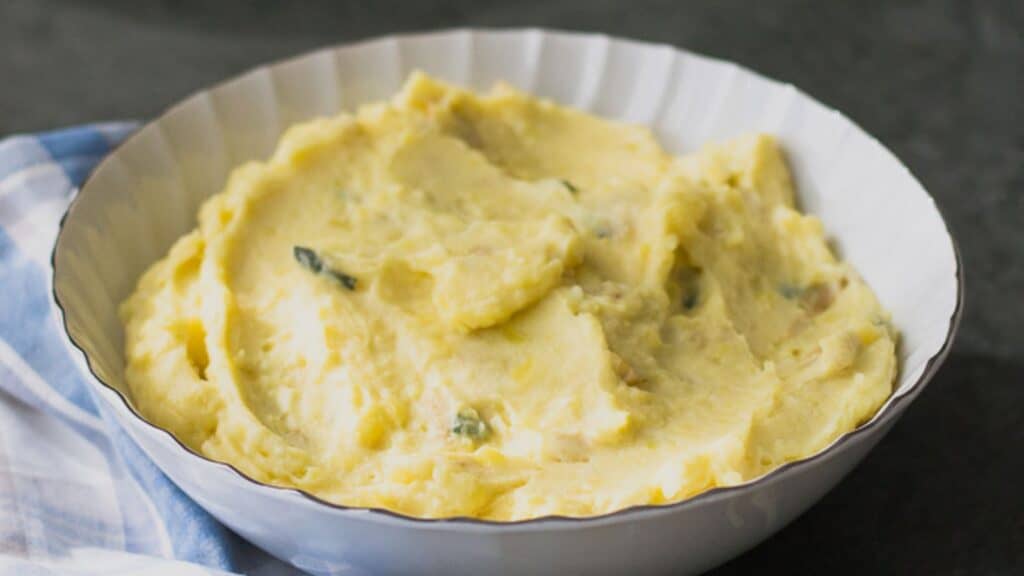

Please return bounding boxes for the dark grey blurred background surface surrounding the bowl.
[0,0,1024,576]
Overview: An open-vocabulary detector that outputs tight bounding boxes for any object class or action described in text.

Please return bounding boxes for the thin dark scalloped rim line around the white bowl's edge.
[50,28,964,528]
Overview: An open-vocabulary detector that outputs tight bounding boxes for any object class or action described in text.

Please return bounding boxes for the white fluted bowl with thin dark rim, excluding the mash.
[53,30,962,574]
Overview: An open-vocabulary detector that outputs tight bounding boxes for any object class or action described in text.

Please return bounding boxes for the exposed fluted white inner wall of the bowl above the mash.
[53,30,958,430]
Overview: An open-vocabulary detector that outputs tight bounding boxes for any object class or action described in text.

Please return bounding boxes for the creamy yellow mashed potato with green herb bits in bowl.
[122,75,897,521]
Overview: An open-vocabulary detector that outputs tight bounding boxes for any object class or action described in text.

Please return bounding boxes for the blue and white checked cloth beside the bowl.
[0,123,294,576]
